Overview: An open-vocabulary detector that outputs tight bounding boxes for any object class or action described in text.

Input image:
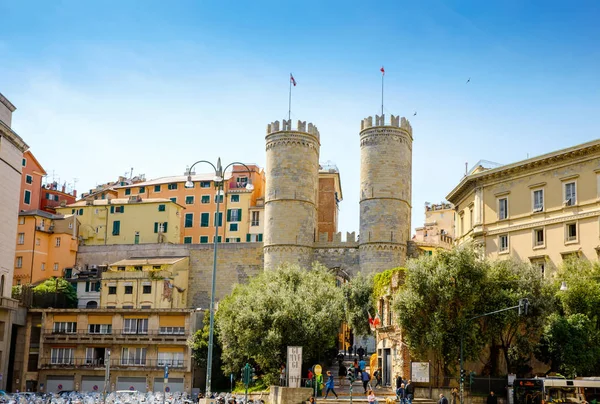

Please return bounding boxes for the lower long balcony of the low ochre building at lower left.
[40,357,188,370]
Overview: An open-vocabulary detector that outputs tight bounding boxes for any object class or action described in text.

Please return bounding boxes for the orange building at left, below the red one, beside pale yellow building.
[13,210,79,285]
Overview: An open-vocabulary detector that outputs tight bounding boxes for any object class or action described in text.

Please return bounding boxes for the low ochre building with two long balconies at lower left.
[11,308,196,393]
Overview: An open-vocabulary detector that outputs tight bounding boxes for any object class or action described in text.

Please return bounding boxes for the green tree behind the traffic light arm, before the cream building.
[480,260,553,374]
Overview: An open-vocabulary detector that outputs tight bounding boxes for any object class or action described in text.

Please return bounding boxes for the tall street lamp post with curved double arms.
[185,157,254,399]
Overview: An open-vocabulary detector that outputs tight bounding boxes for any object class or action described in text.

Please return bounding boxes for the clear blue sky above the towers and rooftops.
[0,0,600,235]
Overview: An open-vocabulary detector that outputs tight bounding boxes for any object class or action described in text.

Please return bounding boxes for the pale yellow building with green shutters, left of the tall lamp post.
[56,196,183,245]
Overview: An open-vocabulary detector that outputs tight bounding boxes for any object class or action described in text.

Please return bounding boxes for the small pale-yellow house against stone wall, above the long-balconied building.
[100,257,189,309]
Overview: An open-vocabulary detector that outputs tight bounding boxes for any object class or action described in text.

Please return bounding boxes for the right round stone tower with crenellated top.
[359,115,413,272]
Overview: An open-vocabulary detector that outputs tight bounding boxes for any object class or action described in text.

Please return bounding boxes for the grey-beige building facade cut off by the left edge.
[0,94,28,390]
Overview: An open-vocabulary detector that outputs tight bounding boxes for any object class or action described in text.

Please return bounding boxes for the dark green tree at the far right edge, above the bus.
[536,313,600,378]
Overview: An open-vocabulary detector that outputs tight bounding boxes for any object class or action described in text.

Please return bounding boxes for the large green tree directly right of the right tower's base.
[393,248,490,374]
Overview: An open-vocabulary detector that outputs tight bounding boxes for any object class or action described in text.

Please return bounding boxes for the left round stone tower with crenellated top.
[263,120,321,270]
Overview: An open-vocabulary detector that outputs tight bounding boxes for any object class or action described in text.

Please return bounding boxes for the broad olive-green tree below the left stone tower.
[216,265,343,383]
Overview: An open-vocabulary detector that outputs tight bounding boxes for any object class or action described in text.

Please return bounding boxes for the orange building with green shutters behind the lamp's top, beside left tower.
[114,165,265,244]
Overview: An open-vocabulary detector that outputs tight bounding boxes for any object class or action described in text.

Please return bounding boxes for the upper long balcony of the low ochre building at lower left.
[42,329,190,344]
